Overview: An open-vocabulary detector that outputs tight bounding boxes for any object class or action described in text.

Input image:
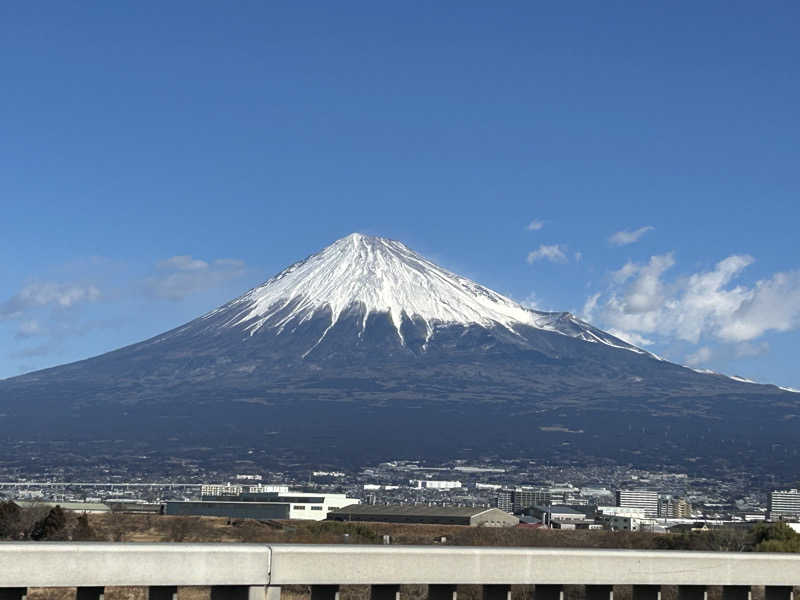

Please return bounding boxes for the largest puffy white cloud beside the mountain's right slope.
[584,253,800,346]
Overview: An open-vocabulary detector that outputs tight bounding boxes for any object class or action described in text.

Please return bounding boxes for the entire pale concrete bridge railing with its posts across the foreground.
[0,542,800,600]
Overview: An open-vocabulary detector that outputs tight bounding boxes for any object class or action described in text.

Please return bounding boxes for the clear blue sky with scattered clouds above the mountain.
[0,1,800,388]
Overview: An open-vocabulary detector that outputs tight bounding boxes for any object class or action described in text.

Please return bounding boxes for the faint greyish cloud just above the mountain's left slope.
[145,255,245,300]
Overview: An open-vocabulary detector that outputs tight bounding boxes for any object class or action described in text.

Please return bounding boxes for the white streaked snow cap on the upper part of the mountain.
[206,233,646,354]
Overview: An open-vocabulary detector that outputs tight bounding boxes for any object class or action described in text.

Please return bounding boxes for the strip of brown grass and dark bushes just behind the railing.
[0,502,800,552]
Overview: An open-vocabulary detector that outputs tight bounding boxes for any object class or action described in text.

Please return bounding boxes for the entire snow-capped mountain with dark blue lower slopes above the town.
[0,234,800,471]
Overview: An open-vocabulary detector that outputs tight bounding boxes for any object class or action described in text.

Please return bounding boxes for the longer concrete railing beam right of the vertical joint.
[270,544,800,586]
